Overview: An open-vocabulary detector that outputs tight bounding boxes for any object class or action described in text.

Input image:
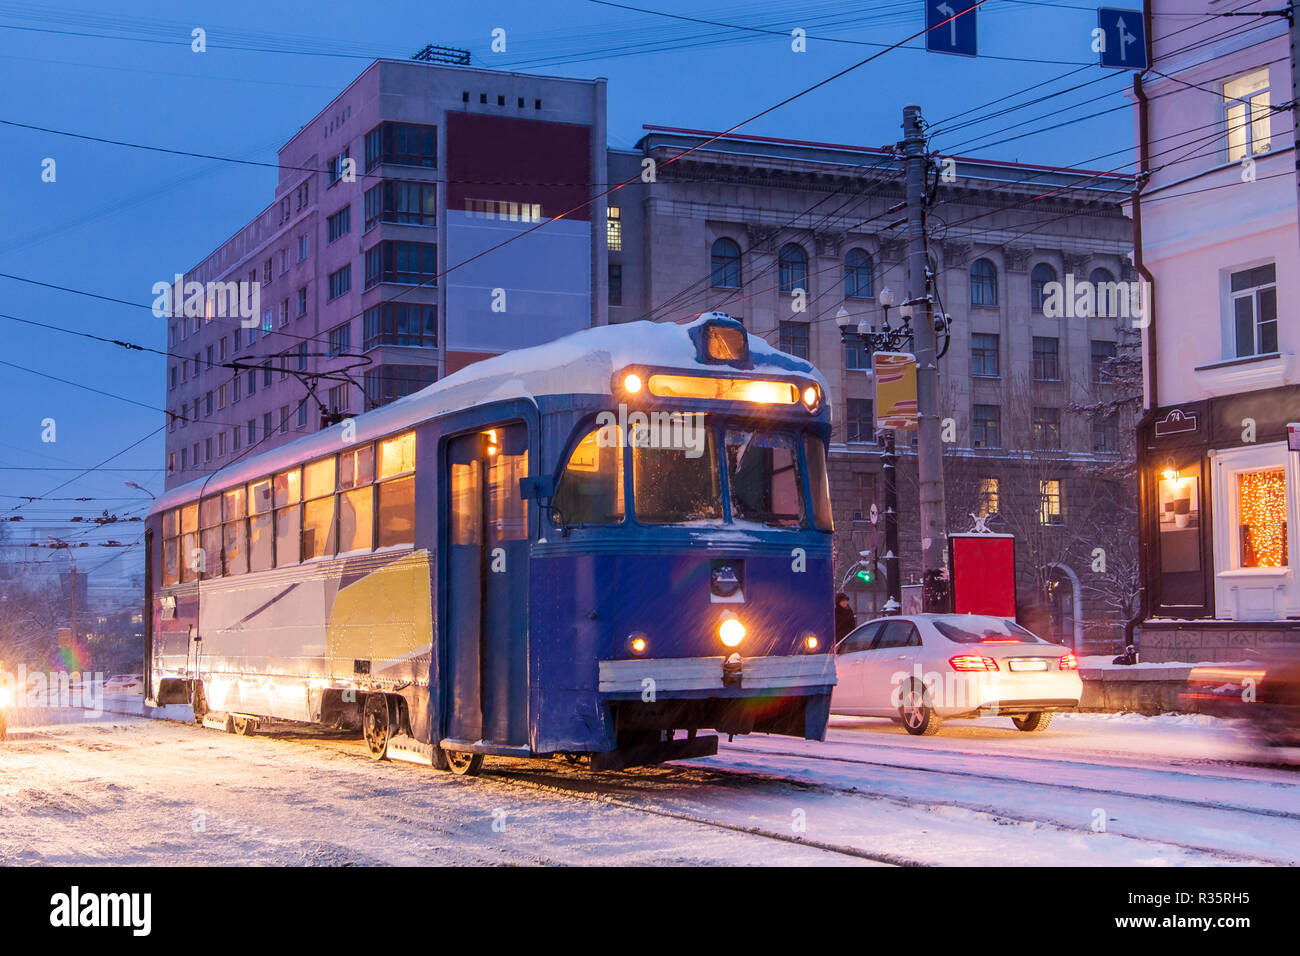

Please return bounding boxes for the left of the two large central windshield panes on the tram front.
[629,427,723,524]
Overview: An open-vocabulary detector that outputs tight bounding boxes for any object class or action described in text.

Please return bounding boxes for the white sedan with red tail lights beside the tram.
[831,614,1083,736]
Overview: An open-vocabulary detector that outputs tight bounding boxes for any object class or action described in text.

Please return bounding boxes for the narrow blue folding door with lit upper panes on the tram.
[447,424,528,747]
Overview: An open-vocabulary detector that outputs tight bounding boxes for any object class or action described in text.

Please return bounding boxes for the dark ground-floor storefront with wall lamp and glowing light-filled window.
[1139,386,1300,661]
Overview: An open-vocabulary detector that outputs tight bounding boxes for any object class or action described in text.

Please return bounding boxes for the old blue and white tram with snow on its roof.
[146,312,835,774]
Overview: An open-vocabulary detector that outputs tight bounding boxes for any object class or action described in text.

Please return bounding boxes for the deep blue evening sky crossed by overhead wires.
[0,0,1138,567]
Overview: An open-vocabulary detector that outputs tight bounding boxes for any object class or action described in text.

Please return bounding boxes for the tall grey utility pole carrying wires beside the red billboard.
[902,107,948,613]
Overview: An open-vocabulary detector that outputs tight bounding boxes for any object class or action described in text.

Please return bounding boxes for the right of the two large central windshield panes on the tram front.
[725,431,803,528]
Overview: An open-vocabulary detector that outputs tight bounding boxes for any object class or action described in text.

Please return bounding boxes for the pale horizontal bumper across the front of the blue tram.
[598,654,835,697]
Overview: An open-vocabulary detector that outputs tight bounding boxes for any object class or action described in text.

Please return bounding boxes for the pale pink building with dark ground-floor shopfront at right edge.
[1131,0,1300,661]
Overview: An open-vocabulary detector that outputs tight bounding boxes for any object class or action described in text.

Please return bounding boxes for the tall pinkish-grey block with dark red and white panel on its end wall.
[166,60,606,486]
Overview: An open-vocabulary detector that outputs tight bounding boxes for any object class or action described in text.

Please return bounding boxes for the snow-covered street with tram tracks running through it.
[0,697,1300,866]
